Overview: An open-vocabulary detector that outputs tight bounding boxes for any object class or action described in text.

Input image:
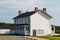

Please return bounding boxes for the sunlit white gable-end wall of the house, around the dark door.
[30,12,52,36]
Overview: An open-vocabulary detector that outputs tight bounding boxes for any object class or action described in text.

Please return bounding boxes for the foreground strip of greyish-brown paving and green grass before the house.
[0,35,60,40]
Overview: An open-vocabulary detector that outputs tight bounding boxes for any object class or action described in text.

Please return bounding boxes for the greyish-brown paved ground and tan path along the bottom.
[0,36,46,40]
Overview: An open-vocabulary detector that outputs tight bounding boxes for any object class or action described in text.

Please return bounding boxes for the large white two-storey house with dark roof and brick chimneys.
[11,7,52,36]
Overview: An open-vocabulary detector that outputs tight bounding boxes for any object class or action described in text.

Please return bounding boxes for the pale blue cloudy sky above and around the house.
[0,0,60,25]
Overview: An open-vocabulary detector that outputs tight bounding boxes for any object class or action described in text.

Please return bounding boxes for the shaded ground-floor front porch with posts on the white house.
[10,25,30,35]
